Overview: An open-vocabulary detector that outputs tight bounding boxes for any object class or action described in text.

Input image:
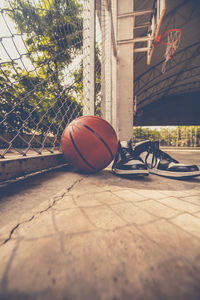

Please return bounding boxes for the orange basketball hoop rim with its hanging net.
[154,28,181,74]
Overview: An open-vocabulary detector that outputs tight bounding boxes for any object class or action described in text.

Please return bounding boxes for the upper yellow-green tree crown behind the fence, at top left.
[9,0,82,71]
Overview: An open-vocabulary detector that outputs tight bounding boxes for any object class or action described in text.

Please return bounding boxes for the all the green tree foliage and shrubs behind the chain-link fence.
[0,0,82,134]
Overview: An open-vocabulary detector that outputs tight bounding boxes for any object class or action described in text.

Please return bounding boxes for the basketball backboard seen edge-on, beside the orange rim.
[147,0,166,65]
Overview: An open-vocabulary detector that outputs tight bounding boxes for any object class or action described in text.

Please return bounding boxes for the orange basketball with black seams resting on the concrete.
[61,116,118,173]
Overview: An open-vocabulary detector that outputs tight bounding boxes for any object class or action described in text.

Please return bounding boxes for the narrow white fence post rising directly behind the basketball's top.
[83,0,96,115]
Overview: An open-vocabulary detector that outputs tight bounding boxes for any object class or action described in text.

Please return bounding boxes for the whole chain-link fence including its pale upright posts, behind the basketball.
[0,0,116,180]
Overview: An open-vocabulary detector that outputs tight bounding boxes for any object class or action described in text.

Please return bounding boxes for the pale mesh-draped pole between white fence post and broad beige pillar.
[101,0,117,129]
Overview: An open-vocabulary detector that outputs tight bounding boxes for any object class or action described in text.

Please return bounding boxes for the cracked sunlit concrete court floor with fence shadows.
[0,150,200,300]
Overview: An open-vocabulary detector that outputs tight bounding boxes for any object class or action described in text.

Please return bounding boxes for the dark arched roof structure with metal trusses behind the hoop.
[134,0,200,125]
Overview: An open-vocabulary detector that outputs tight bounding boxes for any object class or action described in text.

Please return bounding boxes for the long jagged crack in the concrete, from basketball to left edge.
[0,178,84,247]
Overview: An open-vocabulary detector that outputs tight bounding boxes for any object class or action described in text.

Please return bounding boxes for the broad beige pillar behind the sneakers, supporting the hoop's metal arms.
[117,0,134,140]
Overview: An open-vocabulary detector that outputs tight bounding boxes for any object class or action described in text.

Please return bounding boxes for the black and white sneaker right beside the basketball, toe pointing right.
[112,140,149,176]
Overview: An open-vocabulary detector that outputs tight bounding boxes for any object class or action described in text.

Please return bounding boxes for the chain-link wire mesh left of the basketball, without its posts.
[0,0,101,158]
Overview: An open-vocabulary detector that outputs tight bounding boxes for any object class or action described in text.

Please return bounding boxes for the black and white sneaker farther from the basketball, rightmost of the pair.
[135,140,200,178]
